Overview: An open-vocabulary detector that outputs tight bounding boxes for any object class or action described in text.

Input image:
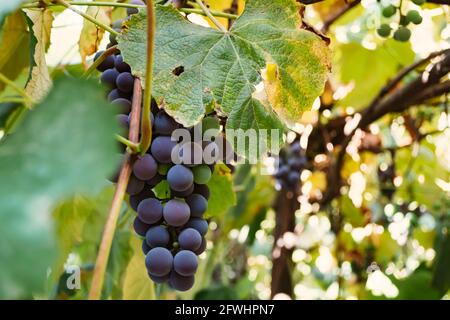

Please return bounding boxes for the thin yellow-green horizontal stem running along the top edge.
[21,1,238,19]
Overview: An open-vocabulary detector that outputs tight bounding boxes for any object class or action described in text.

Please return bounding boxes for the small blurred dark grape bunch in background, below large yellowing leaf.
[275,139,307,191]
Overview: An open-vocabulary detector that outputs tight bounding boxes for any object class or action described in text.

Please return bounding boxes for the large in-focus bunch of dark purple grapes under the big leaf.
[92,1,230,291]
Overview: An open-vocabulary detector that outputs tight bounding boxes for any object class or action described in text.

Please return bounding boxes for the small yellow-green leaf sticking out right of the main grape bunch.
[206,164,236,216]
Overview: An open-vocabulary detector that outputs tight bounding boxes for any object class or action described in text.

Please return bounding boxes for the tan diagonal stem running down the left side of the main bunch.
[89,79,142,300]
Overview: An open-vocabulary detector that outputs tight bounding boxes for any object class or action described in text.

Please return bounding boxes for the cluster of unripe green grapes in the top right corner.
[377,0,426,42]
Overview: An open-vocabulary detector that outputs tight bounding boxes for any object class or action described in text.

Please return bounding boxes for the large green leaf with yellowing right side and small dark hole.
[119,0,329,129]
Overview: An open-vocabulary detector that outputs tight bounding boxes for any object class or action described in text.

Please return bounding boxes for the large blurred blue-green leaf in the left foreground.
[0,79,118,298]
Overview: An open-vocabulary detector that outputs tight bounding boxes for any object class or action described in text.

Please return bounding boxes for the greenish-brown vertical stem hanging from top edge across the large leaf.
[139,0,156,155]
